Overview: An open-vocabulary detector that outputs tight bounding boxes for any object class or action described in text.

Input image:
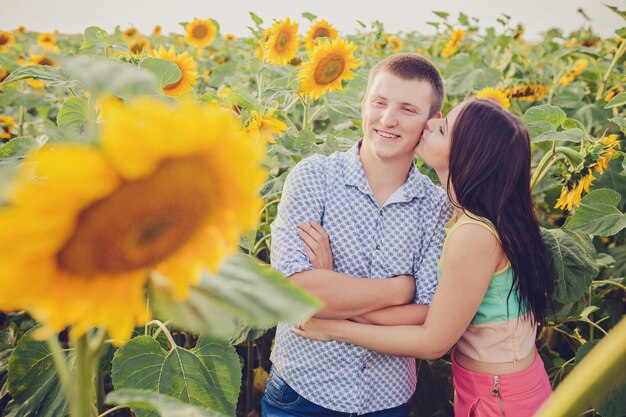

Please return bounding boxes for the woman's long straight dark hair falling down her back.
[448,99,553,323]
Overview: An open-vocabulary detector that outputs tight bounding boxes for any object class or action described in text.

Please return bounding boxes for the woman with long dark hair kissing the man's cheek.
[292,100,552,417]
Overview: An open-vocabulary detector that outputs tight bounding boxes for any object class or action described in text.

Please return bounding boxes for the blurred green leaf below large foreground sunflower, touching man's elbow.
[151,255,320,339]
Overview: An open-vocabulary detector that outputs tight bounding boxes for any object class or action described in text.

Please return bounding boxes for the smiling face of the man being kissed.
[361,71,432,163]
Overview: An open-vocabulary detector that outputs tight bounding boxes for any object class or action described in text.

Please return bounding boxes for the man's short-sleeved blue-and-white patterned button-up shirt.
[271,143,451,414]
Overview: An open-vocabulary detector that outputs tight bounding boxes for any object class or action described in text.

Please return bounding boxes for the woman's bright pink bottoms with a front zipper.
[452,351,552,417]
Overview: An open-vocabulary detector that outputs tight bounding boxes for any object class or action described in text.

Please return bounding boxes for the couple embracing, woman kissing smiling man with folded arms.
[262,54,552,417]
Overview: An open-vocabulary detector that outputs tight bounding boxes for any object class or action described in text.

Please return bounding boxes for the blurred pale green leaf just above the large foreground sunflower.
[62,56,160,99]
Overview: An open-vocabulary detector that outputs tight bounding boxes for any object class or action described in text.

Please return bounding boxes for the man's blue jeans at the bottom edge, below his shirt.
[261,372,411,417]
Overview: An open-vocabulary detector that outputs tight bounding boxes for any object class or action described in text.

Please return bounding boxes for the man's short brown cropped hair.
[365,53,444,117]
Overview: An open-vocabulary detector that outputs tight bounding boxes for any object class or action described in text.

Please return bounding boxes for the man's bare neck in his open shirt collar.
[359,149,413,207]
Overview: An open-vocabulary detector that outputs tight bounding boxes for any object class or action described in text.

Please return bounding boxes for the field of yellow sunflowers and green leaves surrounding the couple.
[0,7,626,417]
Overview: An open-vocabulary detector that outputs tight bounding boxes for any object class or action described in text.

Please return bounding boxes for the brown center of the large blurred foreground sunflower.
[57,157,213,276]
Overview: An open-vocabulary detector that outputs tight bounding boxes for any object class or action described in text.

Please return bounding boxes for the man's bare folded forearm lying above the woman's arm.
[291,269,415,319]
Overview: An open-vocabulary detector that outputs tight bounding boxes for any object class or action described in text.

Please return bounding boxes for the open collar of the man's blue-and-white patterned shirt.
[344,140,425,201]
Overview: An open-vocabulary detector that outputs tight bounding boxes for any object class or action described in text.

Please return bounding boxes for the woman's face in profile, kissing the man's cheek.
[415,103,465,173]
